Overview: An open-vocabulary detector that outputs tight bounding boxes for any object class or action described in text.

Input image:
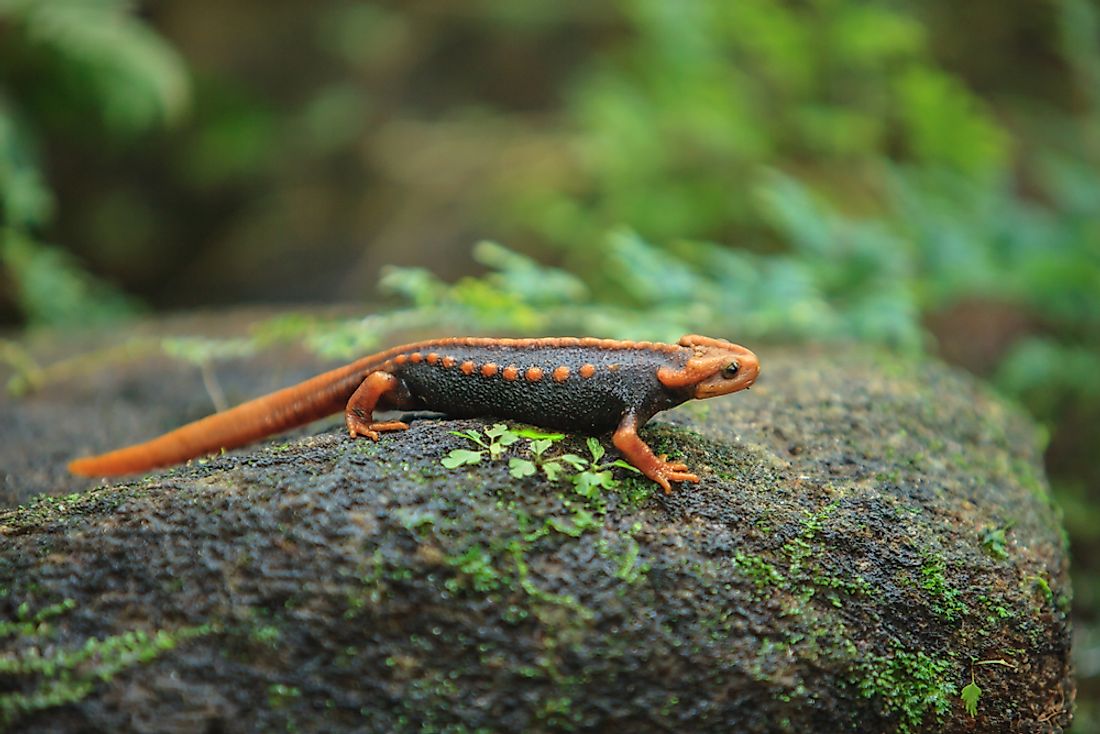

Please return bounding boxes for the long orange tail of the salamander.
[68,357,378,476]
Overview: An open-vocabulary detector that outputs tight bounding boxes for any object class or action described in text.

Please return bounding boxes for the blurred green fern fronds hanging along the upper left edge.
[0,0,188,326]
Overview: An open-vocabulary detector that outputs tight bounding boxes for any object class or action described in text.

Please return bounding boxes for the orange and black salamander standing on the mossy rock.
[68,335,760,493]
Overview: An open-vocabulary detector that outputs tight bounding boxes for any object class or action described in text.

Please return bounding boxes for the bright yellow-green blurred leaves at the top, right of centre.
[506,0,1009,248]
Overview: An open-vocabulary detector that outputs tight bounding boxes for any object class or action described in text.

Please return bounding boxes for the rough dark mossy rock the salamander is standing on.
[0,327,1074,732]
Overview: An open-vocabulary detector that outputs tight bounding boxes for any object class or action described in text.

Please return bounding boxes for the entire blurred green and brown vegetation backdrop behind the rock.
[0,0,1100,731]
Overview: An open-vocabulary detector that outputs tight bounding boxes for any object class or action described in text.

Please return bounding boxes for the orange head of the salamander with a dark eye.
[657,335,760,399]
